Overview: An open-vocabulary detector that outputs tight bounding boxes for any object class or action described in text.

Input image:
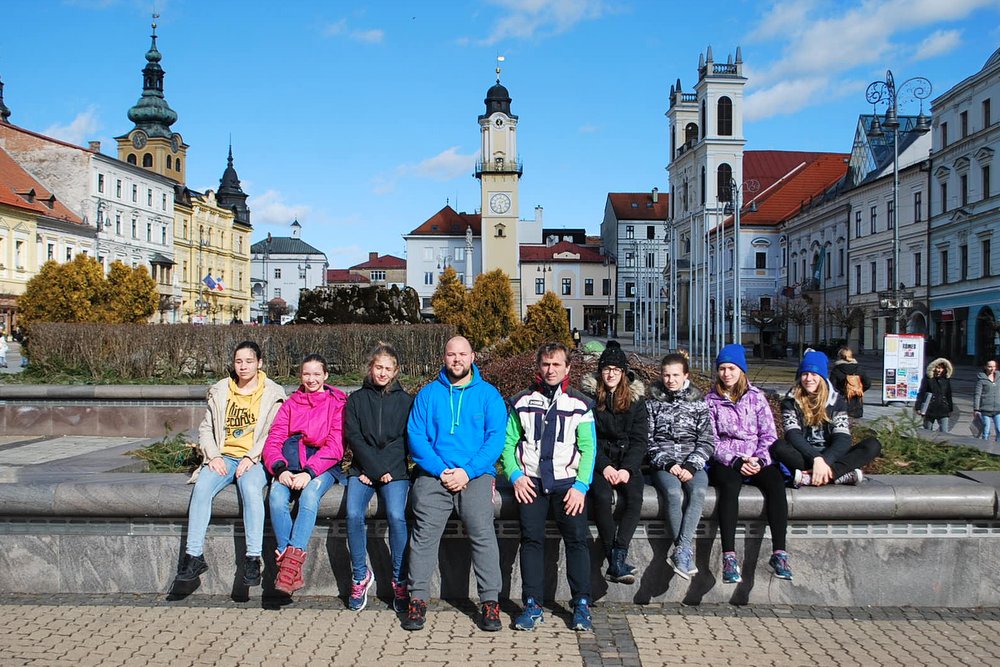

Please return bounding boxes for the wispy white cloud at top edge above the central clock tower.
[483,0,612,44]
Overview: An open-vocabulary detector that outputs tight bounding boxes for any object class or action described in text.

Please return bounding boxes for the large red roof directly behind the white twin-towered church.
[740,151,850,225]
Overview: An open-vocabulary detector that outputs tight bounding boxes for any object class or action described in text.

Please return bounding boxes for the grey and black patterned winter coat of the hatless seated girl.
[646,380,715,473]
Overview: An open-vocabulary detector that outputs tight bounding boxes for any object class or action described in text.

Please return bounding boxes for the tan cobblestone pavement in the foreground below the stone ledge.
[0,595,1000,667]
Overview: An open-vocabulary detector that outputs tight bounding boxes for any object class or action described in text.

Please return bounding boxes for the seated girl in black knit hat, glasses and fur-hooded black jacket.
[583,340,647,584]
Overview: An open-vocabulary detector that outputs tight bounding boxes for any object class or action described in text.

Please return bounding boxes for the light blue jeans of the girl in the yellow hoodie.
[186,456,267,556]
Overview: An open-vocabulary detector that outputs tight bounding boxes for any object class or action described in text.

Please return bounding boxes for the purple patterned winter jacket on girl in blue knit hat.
[705,385,778,466]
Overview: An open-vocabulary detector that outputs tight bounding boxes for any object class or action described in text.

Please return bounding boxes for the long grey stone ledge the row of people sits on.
[0,473,1000,607]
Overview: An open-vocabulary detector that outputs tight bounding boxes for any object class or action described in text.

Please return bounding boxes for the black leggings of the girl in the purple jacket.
[708,461,788,551]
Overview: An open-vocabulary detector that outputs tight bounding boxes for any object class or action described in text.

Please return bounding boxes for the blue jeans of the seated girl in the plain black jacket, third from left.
[347,477,410,581]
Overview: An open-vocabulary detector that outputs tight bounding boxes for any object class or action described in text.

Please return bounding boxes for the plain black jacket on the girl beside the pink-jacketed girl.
[344,377,413,481]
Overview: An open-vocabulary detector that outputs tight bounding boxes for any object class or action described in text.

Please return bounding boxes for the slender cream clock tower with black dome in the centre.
[476,57,522,286]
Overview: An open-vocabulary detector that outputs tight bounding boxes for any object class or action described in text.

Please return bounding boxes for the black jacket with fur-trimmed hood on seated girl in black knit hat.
[581,373,648,476]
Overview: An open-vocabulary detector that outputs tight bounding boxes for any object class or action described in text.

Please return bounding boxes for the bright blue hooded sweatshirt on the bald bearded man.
[407,364,507,479]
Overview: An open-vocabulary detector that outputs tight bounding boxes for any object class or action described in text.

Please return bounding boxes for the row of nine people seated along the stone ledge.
[175,336,880,631]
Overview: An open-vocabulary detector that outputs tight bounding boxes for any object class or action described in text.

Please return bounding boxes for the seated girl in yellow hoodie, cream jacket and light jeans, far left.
[175,341,285,586]
